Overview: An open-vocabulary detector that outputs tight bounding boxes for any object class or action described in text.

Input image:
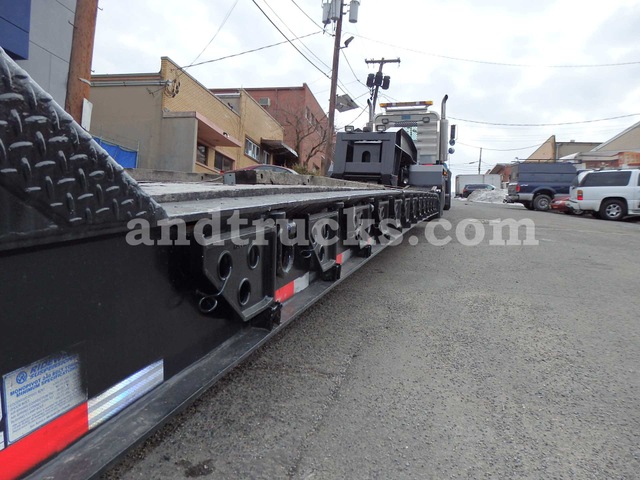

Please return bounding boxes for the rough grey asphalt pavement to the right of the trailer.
[103,201,640,480]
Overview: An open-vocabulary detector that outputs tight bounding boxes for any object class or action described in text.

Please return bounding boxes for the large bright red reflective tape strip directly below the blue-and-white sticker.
[0,402,89,480]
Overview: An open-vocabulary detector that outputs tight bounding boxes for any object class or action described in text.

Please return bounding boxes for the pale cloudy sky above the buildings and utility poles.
[93,0,640,174]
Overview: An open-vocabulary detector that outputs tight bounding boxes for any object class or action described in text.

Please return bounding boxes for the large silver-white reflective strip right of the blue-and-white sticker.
[88,360,164,430]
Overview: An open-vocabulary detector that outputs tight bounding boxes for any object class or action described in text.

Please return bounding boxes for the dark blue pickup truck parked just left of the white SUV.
[507,162,577,211]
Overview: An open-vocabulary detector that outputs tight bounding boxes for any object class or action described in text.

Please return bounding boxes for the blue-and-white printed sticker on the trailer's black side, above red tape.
[2,353,87,445]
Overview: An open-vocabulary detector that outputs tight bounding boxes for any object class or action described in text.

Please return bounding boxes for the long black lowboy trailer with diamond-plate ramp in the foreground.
[0,50,448,480]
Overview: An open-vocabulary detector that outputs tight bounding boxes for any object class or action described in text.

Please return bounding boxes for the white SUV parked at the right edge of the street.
[569,169,640,220]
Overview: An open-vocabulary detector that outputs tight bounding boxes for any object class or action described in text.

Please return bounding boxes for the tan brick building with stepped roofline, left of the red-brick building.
[90,57,292,173]
